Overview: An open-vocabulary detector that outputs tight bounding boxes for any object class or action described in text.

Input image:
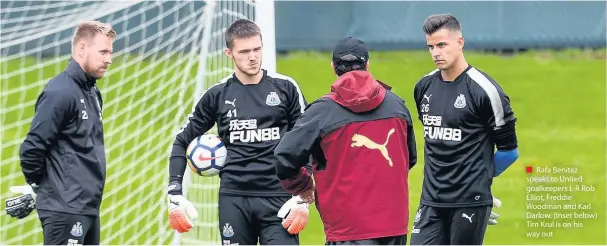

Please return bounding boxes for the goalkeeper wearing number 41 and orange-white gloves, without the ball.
[168,19,311,245]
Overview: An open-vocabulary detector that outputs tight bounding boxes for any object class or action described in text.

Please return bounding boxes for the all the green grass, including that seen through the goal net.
[0,50,607,245]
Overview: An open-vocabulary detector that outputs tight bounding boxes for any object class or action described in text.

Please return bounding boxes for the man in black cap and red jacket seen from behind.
[274,38,417,244]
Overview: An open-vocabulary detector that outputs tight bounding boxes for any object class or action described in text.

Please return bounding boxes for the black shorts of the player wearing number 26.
[411,205,491,245]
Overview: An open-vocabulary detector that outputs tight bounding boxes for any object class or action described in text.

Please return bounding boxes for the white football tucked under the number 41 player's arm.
[186,134,228,177]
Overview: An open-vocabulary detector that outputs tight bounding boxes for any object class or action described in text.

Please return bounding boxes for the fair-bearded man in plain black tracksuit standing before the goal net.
[6,22,116,245]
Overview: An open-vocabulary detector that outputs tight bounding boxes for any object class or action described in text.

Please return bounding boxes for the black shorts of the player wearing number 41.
[219,195,299,245]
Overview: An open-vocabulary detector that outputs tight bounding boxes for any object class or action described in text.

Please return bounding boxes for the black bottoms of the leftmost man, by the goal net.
[38,210,101,245]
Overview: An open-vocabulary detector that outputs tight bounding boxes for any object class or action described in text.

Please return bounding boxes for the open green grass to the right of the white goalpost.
[286,50,606,245]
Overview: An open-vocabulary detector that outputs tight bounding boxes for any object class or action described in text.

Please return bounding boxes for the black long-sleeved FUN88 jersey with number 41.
[170,70,311,196]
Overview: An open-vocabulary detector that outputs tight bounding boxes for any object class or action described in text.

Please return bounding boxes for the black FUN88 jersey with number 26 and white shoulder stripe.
[414,66,516,207]
